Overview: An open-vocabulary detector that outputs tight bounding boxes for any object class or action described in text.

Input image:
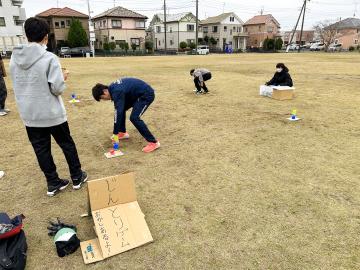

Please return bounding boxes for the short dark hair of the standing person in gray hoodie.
[24,17,50,42]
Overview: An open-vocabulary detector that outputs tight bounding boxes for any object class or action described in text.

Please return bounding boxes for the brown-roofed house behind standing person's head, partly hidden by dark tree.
[36,7,89,52]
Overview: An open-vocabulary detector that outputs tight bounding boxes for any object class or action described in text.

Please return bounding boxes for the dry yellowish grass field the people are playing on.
[0,53,360,269]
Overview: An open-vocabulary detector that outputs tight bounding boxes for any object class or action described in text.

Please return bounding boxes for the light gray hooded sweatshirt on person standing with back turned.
[10,43,67,127]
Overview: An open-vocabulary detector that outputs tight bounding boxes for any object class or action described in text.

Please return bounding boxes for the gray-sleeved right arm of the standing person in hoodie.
[47,57,66,96]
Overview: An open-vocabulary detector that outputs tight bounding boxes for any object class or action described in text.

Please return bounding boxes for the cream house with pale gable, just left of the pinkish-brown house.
[200,12,247,51]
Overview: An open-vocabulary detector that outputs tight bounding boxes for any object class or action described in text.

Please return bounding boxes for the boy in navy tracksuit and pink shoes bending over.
[92,78,160,153]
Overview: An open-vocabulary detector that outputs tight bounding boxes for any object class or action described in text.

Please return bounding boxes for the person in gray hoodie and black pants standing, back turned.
[10,18,87,196]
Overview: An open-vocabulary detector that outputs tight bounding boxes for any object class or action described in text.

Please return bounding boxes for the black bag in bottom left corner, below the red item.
[0,230,27,270]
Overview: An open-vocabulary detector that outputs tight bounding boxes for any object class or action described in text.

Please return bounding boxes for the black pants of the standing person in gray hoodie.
[26,122,82,187]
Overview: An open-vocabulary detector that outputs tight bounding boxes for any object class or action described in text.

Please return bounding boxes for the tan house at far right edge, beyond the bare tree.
[331,18,360,50]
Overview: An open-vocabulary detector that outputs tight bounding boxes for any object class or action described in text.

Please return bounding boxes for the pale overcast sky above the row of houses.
[23,0,360,30]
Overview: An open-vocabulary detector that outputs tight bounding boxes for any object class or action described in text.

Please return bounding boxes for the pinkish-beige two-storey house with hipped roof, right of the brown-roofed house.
[93,7,148,49]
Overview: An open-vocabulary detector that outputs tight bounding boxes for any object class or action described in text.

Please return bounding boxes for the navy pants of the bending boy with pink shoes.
[118,92,156,142]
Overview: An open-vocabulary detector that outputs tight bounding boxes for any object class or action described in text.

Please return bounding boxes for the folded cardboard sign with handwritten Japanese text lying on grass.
[81,173,153,264]
